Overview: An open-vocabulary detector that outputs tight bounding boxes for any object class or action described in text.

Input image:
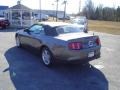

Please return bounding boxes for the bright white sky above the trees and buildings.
[0,0,120,13]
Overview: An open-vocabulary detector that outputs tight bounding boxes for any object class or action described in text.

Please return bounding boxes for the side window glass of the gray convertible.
[29,25,44,34]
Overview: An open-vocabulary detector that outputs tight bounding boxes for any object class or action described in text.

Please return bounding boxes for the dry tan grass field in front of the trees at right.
[49,18,120,35]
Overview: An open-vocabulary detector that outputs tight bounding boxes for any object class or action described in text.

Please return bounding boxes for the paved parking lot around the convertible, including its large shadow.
[0,29,120,90]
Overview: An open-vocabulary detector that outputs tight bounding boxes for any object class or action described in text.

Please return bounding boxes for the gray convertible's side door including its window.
[20,24,44,49]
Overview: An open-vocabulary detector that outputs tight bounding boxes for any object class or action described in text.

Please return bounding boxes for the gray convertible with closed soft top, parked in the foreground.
[15,22,101,66]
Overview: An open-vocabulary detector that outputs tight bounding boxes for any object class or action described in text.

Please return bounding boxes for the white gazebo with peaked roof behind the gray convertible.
[6,1,35,27]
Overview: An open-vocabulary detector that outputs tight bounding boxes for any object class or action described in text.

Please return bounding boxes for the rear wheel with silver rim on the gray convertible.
[41,47,53,66]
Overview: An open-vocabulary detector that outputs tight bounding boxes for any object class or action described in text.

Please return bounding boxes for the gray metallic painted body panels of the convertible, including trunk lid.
[16,22,101,61]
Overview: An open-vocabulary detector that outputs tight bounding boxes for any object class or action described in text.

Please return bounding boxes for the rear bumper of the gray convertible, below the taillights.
[55,47,101,62]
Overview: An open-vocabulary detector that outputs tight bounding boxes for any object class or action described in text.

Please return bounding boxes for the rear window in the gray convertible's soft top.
[56,26,84,34]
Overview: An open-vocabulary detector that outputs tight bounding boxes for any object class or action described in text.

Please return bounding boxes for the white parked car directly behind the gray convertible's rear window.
[71,16,88,32]
